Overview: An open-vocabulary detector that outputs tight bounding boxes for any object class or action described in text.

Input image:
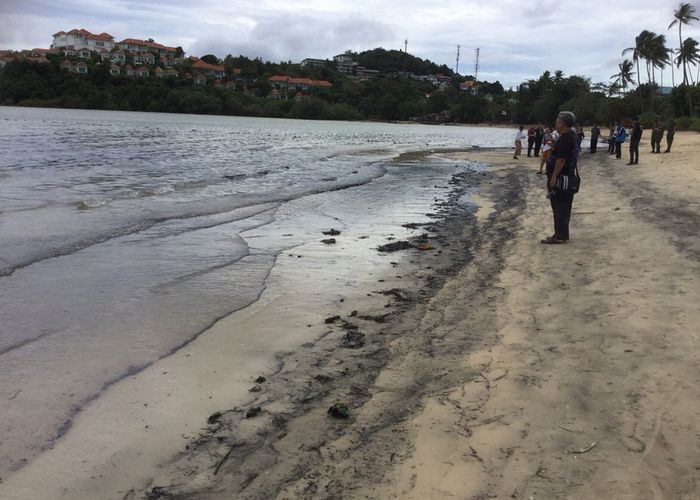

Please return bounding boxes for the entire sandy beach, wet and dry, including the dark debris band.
[0,133,700,499]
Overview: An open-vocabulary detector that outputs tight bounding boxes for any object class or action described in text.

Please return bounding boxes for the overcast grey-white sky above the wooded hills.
[0,0,700,87]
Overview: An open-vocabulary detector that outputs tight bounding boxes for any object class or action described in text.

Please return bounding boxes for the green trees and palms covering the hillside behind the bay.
[0,15,700,131]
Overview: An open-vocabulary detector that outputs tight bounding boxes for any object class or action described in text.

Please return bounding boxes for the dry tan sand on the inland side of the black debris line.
[148,134,700,499]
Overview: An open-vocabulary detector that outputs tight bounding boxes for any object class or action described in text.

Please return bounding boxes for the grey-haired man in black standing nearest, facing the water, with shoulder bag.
[540,111,577,245]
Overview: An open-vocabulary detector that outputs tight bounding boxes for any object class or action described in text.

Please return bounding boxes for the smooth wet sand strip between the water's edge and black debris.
[0,150,492,498]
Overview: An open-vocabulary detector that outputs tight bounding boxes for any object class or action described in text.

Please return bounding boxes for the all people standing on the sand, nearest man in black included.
[513,111,675,244]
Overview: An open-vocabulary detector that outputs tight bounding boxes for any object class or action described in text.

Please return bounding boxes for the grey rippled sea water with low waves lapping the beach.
[0,107,512,475]
